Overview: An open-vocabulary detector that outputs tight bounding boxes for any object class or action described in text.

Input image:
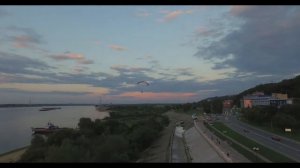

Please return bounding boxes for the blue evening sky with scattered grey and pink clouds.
[0,5,300,104]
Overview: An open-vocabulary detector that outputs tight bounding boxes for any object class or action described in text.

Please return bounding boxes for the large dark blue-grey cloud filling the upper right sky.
[195,6,300,75]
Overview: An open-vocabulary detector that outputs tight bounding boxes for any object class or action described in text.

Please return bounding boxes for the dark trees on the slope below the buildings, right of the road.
[241,104,300,132]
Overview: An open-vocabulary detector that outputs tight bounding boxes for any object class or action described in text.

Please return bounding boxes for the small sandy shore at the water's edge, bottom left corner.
[0,147,28,163]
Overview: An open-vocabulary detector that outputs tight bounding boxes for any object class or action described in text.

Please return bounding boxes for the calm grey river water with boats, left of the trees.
[0,106,109,154]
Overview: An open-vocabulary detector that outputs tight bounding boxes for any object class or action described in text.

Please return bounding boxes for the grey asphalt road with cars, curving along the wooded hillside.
[219,116,300,162]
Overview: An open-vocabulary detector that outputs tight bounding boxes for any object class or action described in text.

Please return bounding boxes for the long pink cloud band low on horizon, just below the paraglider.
[119,92,197,100]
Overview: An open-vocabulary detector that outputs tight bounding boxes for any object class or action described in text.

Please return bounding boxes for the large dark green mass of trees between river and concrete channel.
[20,106,169,162]
